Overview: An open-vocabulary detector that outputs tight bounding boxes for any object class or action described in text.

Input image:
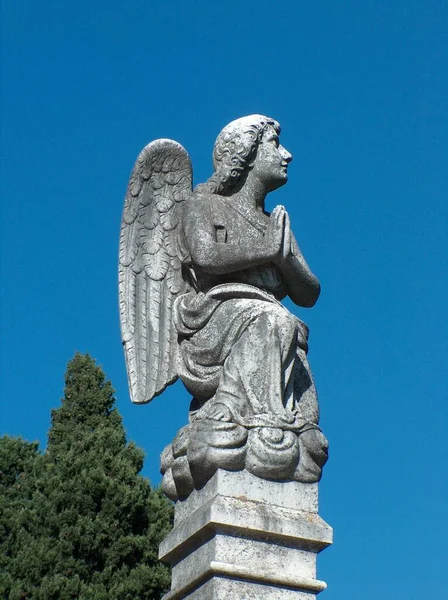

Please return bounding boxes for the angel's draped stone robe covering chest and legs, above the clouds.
[174,197,318,429]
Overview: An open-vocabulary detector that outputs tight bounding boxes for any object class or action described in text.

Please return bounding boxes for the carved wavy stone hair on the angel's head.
[205,115,280,196]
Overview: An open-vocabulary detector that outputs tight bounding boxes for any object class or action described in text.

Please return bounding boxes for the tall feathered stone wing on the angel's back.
[119,139,192,403]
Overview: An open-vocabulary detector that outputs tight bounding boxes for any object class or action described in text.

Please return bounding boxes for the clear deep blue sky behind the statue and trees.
[1,0,448,600]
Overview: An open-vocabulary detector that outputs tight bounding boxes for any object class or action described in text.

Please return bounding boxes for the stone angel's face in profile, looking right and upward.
[252,127,292,192]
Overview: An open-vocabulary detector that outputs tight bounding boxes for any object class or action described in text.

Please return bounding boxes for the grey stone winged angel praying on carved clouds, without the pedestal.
[119,115,328,500]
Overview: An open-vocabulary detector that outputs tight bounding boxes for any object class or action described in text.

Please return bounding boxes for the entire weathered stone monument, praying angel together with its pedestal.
[119,115,332,600]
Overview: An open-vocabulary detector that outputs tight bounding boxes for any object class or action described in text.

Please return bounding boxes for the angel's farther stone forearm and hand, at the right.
[277,213,320,308]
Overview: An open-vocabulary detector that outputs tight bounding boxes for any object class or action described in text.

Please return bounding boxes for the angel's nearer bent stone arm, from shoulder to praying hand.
[183,198,283,275]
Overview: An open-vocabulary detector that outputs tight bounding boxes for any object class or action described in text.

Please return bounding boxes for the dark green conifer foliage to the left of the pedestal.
[0,354,172,600]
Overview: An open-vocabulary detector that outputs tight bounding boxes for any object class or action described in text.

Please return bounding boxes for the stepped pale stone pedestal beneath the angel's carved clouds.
[159,470,333,600]
